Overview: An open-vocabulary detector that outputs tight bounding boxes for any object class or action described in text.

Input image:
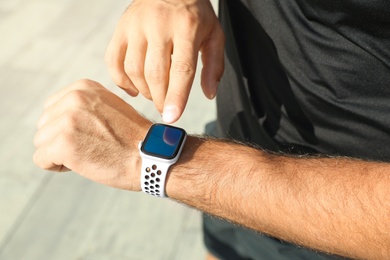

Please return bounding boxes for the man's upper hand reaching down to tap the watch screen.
[106,0,225,123]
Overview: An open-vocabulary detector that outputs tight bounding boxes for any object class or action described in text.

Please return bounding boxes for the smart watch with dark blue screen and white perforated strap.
[138,124,187,197]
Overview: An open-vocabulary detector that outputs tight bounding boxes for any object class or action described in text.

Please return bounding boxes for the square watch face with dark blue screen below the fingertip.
[141,124,186,159]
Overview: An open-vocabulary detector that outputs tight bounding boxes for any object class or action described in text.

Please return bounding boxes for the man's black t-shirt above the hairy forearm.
[217,0,390,161]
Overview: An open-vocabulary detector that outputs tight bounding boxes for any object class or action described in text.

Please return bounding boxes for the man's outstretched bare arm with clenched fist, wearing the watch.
[34,80,390,259]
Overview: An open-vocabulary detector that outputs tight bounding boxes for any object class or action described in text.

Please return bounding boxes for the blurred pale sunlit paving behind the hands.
[0,0,216,260]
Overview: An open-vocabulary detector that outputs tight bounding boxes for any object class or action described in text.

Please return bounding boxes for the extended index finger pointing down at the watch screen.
[163,40,199,123]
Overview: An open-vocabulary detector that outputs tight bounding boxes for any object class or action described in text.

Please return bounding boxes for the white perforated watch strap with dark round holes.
[141,158,170,198]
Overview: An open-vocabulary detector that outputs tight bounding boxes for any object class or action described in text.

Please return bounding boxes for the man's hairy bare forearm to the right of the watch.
[167,137,390,259]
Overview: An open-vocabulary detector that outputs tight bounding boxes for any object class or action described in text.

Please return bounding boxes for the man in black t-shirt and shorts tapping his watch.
[34,0,390,259]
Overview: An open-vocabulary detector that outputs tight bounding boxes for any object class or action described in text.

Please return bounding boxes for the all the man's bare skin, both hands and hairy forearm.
[34,0,390,259]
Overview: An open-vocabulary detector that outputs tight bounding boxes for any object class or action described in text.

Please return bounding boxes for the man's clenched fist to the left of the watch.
[34,80,151,191]
